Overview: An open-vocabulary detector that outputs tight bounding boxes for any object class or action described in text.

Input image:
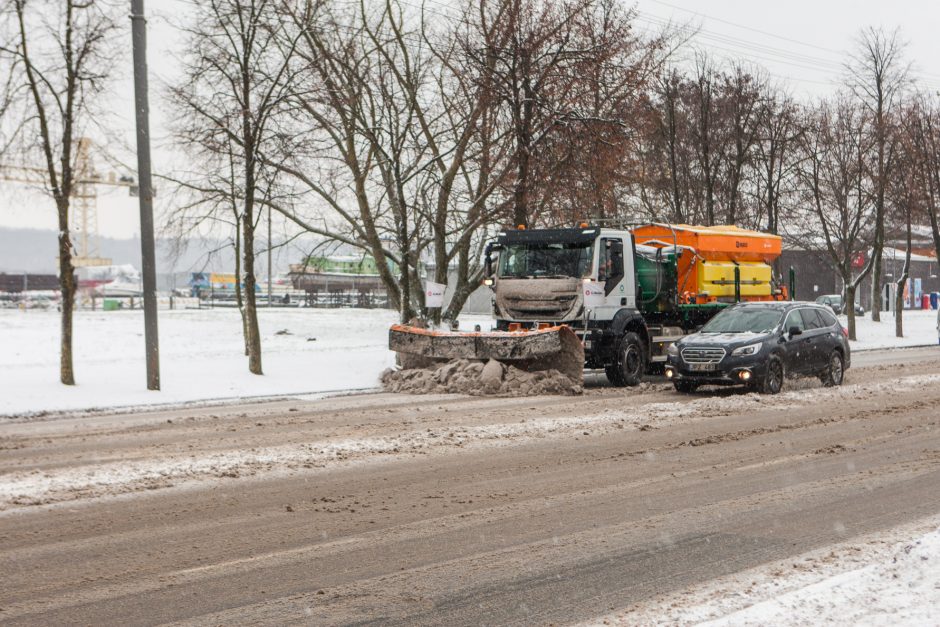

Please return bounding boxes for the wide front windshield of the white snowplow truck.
[499,242,593,279]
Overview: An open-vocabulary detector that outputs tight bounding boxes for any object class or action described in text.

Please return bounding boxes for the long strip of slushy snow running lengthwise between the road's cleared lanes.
[0,375,940,511]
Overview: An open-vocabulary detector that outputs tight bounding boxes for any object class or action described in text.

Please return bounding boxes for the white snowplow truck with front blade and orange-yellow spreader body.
[389,224,793,386]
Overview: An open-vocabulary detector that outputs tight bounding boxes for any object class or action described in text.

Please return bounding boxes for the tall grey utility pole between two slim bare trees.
[131,0,160,390]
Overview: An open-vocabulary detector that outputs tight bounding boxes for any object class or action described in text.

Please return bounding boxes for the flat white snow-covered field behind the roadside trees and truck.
[0,309,937,415]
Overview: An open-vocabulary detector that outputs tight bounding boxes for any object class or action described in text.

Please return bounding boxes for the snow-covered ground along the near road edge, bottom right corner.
[587,517,940,627]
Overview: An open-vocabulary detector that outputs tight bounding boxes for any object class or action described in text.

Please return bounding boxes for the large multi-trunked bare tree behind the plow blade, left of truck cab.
[268,1,509,320]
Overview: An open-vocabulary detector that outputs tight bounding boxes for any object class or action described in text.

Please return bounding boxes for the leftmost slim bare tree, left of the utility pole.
[0,0,115,385]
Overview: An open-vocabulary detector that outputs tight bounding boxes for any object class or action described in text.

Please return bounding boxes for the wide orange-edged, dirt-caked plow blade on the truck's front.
[388,324,584,381]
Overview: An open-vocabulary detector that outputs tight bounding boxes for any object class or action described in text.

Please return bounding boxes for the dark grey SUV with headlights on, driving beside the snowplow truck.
[666,302,851,394]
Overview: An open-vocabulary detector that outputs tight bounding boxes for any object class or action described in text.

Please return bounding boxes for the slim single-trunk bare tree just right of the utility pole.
[171,0,296,375]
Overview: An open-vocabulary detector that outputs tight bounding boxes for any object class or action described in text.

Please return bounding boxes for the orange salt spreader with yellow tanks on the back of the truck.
[633,224,788,304]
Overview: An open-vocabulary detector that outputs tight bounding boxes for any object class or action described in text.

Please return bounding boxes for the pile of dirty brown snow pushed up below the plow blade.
[382,359,584,396]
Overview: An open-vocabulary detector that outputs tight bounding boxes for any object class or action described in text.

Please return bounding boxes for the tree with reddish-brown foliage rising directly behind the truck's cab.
[480,0,670,225]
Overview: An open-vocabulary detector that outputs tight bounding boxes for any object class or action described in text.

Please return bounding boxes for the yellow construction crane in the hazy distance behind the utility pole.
[0,137,138,268]
